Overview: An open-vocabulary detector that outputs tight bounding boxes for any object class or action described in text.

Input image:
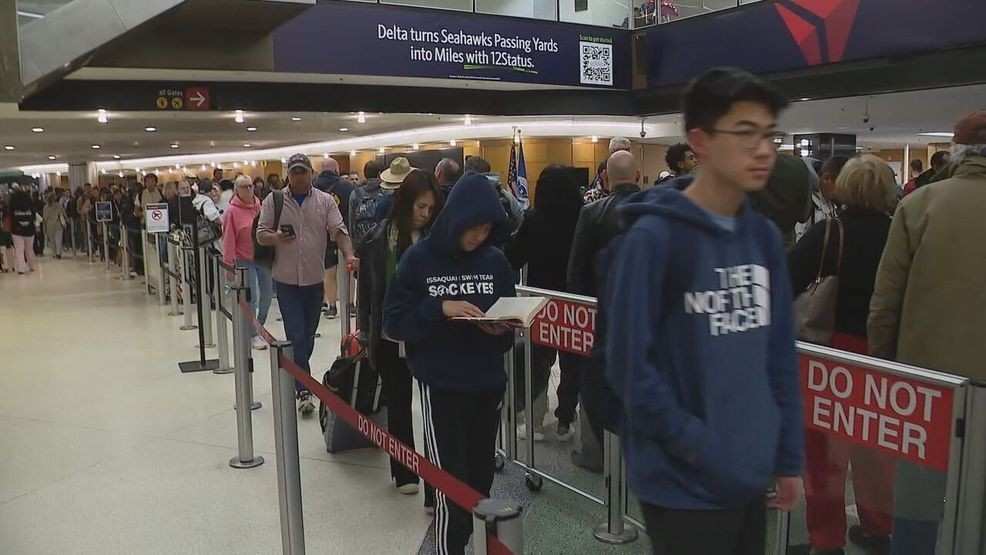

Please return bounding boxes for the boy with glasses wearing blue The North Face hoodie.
[602,69,804,555]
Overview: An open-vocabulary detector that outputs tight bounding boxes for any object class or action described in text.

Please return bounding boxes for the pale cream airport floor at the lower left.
[0,258,431,555]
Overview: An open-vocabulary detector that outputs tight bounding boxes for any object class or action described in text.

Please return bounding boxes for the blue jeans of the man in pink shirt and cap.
[274,281,324,392]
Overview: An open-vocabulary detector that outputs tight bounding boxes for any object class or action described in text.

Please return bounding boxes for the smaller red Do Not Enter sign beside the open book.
[531,299,596,356]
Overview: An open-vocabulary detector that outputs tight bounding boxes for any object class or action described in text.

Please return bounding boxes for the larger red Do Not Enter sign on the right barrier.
[800,354,953,472]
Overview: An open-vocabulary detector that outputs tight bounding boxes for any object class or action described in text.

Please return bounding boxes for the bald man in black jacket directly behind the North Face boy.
[568,150,640,470]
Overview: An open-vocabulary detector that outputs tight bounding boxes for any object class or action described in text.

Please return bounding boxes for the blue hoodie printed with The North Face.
[601,187,804,510]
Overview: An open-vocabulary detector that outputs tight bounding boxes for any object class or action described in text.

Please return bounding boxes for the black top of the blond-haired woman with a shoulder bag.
[788,208,891,337]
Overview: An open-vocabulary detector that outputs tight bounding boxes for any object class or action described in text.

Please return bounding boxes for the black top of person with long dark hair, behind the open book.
[504,206,577,291]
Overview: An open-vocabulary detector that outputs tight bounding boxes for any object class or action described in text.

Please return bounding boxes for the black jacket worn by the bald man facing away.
[567,183,640,297]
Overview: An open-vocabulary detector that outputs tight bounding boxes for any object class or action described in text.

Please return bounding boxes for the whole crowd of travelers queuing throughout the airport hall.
[0,65,986,555]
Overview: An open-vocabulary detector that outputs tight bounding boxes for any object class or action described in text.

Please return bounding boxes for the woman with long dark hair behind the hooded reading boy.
[357,170,442,500]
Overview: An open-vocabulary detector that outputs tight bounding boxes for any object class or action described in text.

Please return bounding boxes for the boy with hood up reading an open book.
[384,174,516,555]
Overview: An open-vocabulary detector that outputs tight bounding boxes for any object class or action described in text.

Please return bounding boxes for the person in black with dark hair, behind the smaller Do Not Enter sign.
[505,165,582,440]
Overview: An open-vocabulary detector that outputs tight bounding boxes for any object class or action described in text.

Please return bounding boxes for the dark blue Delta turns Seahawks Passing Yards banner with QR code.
[274,2,631,89]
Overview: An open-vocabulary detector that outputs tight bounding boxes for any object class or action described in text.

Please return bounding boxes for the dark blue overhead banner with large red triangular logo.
[646,0,986,87]
